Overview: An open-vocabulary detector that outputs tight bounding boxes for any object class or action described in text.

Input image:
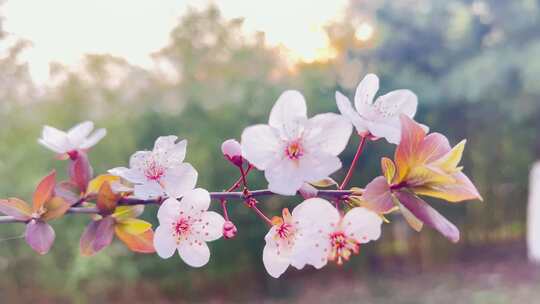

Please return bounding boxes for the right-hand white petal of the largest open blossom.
[303,113,352,156]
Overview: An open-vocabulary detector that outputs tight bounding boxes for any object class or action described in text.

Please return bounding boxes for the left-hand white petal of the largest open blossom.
[241,125,285,170]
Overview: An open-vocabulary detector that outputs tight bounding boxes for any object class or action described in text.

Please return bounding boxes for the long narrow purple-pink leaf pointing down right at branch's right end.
[395,191,459,243]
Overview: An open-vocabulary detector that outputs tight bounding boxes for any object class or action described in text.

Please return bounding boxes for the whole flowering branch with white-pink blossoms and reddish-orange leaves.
[0,74,481,278]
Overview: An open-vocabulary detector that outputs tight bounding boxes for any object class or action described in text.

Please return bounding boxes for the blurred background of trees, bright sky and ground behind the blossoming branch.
[0,0,540,304]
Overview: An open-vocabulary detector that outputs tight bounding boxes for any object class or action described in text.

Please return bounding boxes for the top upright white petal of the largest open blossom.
[268,90,307,134]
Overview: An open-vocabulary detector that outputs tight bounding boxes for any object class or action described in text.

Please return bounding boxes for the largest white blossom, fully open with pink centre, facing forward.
[241,91,352,195]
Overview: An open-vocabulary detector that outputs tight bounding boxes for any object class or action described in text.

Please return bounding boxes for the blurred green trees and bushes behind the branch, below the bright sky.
[0,0,540,302]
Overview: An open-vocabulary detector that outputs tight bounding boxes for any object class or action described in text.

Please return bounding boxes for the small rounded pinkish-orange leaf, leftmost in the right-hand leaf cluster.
[362,176,394,214]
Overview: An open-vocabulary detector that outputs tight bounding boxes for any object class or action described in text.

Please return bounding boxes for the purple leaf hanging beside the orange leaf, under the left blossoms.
[80,217,115,256]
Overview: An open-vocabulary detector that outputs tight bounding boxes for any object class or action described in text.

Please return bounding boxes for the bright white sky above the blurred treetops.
[3,0,350,84]
